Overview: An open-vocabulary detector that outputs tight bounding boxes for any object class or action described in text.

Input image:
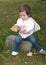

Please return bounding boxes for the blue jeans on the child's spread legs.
[13,34,42,52]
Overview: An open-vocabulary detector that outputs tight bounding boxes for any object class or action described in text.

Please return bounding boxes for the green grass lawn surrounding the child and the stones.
[0,0,46,65]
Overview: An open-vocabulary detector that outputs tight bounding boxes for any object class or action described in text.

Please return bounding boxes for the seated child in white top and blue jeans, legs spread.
[12,4,46,56]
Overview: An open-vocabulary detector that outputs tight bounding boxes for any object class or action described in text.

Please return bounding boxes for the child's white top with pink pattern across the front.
[15,17,40,38]
